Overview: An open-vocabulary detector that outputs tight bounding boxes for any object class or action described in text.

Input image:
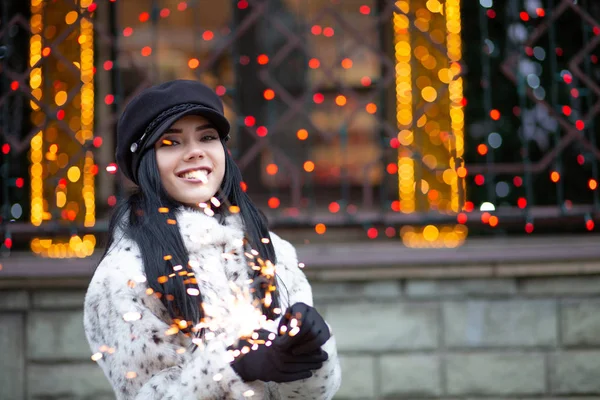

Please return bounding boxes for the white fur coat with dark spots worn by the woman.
[84,210,341,400]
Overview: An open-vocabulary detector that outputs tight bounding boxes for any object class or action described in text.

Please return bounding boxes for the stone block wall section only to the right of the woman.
[313,277,600,399]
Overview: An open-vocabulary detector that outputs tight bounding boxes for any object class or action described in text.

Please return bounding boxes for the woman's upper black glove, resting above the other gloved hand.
[278,303,331,355]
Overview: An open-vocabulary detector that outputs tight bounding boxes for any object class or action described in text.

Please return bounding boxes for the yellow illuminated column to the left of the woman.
[29,0,97,258]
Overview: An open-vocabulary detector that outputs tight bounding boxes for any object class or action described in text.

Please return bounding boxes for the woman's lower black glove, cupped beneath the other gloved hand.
[229,329,327,383]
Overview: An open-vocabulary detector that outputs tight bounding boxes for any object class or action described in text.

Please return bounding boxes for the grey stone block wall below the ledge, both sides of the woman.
[0,276,600,400]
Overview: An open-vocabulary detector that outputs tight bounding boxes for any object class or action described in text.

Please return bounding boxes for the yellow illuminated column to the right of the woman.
[393,0,467,247]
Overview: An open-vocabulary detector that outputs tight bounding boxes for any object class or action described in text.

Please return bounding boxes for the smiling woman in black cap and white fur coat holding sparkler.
[84,80,341,399]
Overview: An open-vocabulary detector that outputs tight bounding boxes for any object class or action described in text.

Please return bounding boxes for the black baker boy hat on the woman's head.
[116,80,230,184]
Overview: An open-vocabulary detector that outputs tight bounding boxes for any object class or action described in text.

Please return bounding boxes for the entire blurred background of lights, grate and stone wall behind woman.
[0,0,600,400]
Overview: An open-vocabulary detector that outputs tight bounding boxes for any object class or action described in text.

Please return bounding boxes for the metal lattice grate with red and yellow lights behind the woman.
[0,0,600,257]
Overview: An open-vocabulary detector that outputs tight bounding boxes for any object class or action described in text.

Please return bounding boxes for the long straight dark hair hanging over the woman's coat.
[101,141,280,333]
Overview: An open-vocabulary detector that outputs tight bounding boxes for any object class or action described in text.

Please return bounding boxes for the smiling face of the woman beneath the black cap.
[154,115,225,207]
